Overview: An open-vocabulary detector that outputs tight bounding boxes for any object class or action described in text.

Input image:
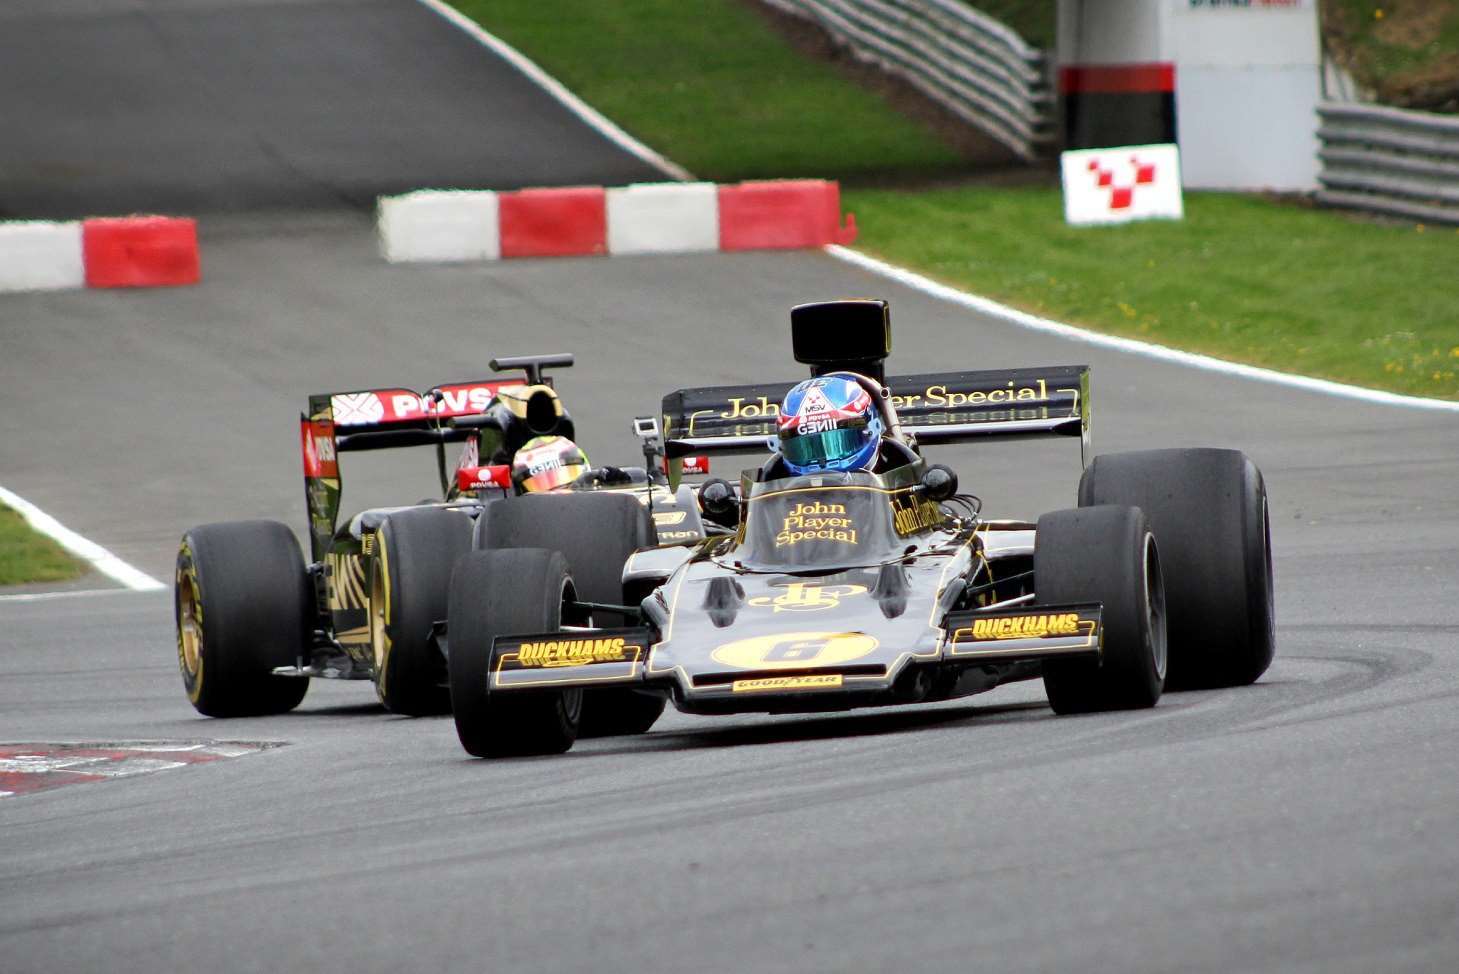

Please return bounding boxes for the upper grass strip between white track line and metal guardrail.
[455,0,963,181]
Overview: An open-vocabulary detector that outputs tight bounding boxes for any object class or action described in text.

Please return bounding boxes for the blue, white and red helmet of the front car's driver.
[772,372,884,474]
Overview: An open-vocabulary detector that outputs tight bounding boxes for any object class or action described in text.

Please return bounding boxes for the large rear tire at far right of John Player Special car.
[1080,449,1277,690]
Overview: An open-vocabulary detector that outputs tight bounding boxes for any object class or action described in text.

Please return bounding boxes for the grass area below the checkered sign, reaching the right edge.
[843,188,1459,400]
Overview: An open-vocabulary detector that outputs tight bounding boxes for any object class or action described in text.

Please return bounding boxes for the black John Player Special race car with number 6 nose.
[446,300,1274,757]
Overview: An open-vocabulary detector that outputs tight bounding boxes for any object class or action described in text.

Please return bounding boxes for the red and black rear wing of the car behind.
[299,376,527,561]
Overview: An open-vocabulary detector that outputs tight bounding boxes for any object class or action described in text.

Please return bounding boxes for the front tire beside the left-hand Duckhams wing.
[446,548,582,758]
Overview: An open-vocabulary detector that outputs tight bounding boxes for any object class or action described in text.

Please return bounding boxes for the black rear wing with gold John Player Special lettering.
[664,366,1091,462]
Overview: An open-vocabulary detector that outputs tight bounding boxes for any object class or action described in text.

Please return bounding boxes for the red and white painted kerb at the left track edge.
[0,741,279,798]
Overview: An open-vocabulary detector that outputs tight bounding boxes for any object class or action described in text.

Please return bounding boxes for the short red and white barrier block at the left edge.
[0,216,201,292]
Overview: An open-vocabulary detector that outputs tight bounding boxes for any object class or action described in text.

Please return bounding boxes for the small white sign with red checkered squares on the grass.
[1059,146,1185,226]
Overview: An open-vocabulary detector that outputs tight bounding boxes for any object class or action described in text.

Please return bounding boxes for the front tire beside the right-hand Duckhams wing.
[1033,504,1166,713]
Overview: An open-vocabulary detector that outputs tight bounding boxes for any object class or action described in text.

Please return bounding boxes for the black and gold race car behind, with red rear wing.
[175,354,705,732]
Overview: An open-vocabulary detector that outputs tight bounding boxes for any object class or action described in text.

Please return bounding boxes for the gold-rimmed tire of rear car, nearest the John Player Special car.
[369,509,471,717]
